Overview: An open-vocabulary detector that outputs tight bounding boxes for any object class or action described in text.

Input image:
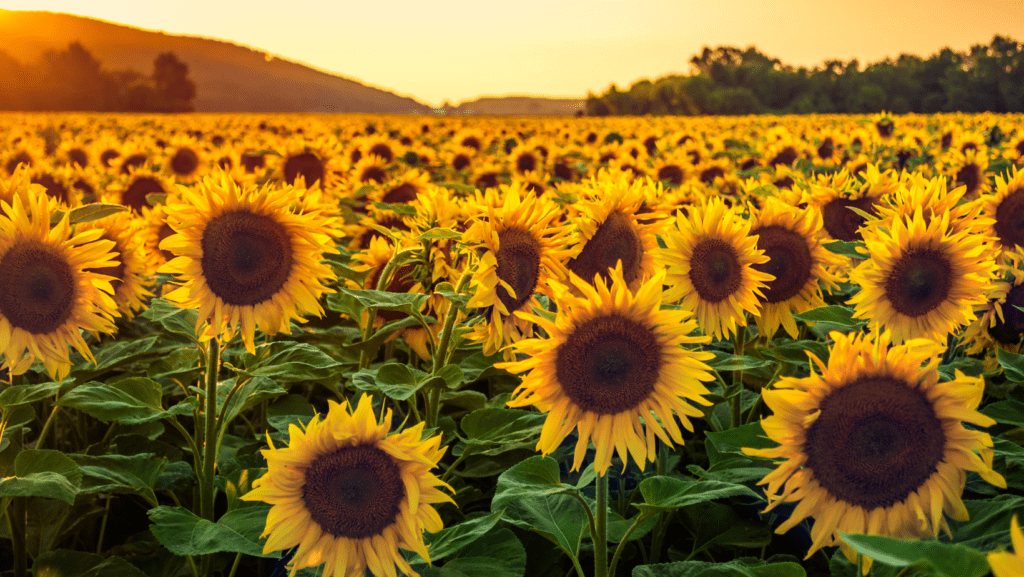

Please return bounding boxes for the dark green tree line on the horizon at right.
[587,36,1024,116]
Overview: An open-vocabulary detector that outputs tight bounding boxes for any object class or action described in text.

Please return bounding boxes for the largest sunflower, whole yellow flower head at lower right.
[743,332,1007,569]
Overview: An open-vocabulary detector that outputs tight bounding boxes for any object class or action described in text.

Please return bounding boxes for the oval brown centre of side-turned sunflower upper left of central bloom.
[495,226,541,315]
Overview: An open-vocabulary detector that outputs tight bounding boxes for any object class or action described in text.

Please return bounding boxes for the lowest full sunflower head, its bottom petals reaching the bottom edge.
[242,395,454,577]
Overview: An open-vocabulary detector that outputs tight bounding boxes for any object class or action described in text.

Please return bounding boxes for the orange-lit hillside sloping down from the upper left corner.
[0,9,430,114]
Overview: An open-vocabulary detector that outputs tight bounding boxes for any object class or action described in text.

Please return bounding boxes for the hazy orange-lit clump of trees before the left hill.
[0,42,196,112]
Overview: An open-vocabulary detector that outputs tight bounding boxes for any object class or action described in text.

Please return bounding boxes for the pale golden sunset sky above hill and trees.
[0,0,1024,106]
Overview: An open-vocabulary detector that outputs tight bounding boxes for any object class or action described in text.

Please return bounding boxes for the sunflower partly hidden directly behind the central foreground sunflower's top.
[567,171,660,290]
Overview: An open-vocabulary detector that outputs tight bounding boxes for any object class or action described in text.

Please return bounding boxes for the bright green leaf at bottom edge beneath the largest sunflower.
[838,531,988,577]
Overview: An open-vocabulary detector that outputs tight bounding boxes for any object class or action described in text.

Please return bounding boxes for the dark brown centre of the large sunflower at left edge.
[0,240,76,334]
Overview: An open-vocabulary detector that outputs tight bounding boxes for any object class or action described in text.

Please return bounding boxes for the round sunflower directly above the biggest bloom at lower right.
[850,207,995,343]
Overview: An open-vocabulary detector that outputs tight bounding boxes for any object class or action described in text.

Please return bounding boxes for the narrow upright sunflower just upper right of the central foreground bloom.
[658,197,774,339]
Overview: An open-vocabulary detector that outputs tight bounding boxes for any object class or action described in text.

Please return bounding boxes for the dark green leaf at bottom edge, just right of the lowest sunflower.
[421,529,526,577]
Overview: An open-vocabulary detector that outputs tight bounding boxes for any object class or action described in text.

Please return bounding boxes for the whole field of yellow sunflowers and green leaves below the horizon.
[0,114,1024,577]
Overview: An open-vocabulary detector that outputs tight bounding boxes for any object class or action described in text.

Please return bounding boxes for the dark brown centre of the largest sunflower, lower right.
[805,376,946,510]
